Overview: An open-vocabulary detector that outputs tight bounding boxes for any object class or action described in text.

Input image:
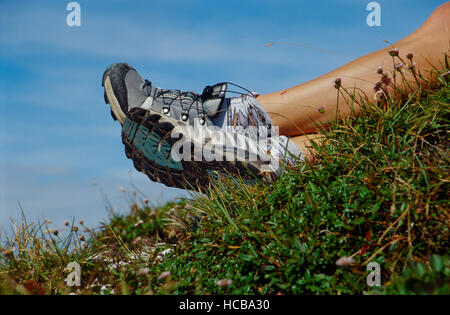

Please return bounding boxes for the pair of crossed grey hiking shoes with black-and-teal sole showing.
[102,63,301,190]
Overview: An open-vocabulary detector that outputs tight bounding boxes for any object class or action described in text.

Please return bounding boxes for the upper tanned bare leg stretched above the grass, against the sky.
[258,2,450,137]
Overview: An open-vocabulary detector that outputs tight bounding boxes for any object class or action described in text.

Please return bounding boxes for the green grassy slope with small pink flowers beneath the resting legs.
[0,52,450,294]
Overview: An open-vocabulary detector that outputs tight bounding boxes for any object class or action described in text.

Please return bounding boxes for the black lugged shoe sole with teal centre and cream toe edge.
[103,69,274,190]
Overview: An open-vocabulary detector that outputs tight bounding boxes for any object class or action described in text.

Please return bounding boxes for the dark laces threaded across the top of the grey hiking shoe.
[143,80,255,125]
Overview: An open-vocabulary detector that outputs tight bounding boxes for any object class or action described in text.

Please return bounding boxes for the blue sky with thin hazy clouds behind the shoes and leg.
[0,0,445,231]
